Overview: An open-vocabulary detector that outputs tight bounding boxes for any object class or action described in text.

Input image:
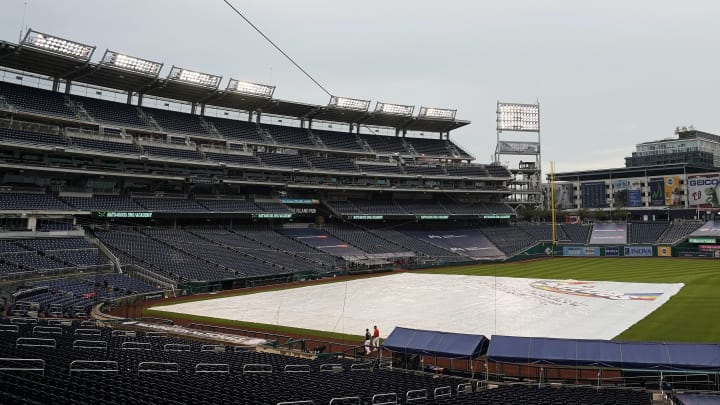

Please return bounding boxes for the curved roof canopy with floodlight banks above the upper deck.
[0,30,470,133]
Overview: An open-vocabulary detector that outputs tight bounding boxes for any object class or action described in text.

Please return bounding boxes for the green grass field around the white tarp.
[144,258,720,343]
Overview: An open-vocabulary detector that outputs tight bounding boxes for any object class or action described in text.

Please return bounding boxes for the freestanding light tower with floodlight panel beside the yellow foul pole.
[495,101,543,208]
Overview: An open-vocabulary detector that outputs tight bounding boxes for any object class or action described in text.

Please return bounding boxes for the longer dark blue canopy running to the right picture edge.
[487,335,720,370]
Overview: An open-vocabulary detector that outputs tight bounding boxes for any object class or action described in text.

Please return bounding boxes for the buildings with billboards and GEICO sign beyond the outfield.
[555,127,720,219]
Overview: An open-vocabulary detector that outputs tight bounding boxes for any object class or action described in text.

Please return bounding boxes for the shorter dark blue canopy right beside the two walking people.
[383,326,488,359]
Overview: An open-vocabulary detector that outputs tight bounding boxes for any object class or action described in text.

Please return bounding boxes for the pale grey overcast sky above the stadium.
[0,0,720,172]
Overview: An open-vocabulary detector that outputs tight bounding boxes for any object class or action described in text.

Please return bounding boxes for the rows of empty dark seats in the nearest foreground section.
[0,320,652,405]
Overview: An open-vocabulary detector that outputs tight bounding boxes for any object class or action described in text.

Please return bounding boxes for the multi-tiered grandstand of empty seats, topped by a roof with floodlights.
[0,30,521,289]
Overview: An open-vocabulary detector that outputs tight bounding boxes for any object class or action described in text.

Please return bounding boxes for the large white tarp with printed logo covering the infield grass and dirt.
[153,273,683,339]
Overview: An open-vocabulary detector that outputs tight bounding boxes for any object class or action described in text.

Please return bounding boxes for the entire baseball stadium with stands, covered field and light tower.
[0,9,720,405]
